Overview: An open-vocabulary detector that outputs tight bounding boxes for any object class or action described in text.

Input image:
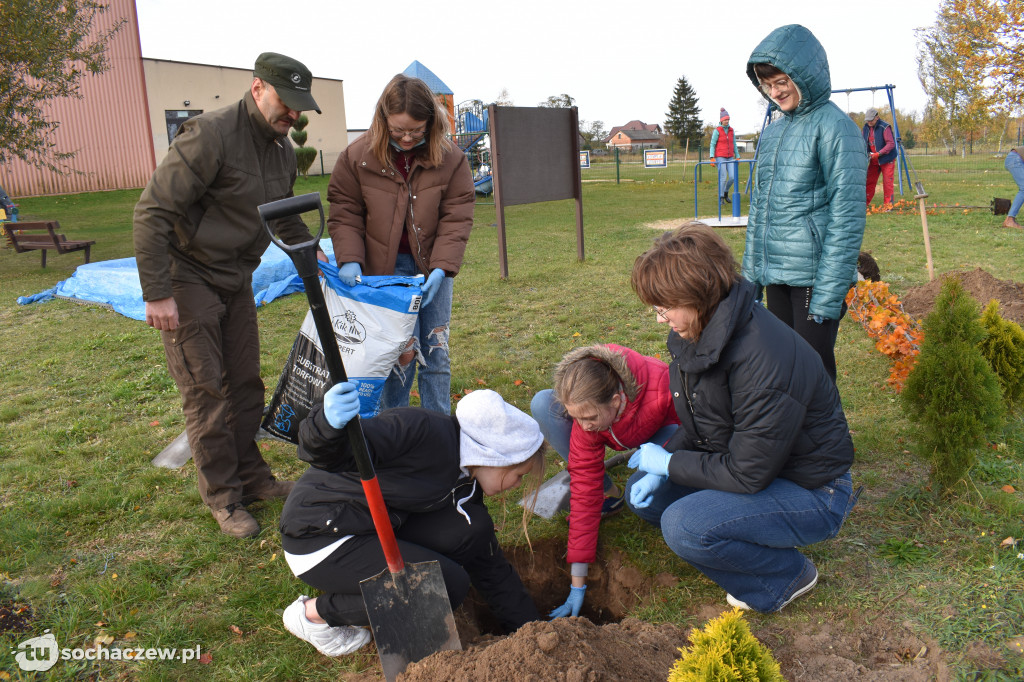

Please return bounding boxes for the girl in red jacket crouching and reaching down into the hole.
[529,344,679,617]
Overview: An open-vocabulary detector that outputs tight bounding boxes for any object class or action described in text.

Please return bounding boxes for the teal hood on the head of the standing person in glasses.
[746,24,831,116]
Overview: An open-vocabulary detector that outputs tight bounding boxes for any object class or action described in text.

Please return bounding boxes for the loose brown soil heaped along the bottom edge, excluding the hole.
[398,605,950,682]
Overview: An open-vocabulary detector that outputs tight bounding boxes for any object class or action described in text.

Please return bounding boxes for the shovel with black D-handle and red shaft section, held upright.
[257,193,462,682]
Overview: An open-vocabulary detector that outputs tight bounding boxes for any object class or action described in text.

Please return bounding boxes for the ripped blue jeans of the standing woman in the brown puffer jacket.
[381,253,454,415]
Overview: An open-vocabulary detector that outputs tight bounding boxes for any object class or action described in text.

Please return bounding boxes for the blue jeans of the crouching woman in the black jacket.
[626,471,856,612]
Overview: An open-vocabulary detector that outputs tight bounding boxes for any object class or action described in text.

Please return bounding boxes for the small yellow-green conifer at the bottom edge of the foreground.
[669,608,785,682]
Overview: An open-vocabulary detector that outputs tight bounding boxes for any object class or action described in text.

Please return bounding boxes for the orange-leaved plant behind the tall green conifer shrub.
[846,281,924,393]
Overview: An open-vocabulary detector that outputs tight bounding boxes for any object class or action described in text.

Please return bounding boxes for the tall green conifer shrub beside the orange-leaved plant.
[900,276,1005,493]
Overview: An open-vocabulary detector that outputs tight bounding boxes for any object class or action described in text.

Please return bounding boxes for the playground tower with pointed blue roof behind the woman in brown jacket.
[402,60,494,196]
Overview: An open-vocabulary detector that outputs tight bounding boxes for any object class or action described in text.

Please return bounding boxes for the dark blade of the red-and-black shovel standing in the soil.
[359,561,462,682]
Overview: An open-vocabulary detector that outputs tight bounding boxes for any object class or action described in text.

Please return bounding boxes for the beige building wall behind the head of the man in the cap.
[142,55,348,175]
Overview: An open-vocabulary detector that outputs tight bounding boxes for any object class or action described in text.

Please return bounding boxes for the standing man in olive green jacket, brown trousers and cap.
[133,52,326,538]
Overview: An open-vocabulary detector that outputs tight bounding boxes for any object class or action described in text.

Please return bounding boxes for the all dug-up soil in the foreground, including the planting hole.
[385,543,949,682]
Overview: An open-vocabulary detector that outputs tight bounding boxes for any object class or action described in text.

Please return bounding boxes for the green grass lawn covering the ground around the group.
[0,171,1024,680]
